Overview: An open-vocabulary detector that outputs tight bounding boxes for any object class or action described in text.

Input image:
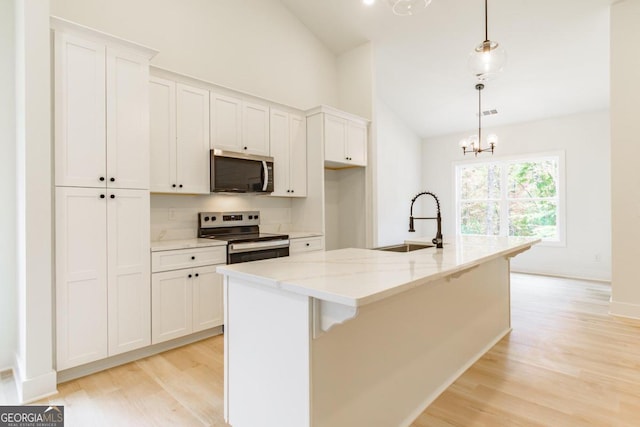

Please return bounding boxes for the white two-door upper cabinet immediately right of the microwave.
[270,108,307,197]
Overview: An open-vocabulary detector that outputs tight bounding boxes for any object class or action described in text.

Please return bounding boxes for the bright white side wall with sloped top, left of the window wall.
[374,99,424,246]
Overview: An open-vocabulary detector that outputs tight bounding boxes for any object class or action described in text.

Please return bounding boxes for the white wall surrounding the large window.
[422,111,612,280]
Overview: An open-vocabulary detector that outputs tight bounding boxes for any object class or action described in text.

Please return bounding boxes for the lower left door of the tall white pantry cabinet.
[56,187,107,370]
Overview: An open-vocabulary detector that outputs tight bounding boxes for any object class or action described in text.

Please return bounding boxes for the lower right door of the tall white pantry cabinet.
[107,189,151,356]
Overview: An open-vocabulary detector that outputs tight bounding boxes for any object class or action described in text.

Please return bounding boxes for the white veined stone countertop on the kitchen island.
[217,236,540,307]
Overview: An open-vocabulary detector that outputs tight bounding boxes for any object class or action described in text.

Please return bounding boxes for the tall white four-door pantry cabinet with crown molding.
[51,17,156,370]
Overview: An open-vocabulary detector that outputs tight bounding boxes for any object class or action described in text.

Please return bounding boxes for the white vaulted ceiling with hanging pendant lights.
[281,0,613,137]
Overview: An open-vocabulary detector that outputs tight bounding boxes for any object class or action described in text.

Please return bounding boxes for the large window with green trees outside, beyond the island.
[455,153,564,244]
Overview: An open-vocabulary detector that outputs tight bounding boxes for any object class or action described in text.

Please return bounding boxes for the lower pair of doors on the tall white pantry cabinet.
[56,187,151,370]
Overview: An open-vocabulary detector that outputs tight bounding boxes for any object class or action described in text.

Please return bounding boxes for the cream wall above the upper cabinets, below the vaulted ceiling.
[51,0,337,110]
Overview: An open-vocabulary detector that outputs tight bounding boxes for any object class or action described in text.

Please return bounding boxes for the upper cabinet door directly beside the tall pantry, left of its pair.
[149,77,177,193]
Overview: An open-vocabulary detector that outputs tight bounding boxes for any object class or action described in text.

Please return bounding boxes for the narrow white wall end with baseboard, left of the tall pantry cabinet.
[15,0,56,402]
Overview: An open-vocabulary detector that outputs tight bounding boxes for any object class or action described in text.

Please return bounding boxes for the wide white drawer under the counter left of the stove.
[151,246,227,273]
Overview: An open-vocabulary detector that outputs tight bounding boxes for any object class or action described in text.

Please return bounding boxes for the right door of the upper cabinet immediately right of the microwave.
[289,114,307,197]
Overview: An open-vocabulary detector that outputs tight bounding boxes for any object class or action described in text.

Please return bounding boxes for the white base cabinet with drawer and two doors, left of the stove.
[151,246,226,344]
